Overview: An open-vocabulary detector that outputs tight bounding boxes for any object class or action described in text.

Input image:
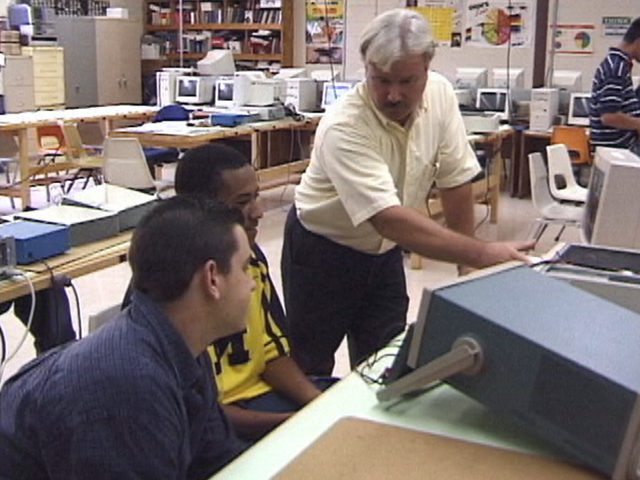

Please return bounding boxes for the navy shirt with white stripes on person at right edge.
[589,47,640,148]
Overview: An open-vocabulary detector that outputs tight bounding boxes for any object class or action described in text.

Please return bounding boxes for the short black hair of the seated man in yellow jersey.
[175,143,251,198]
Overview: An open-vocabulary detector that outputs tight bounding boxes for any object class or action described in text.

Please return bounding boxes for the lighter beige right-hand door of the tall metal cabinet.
[96,18,141,105]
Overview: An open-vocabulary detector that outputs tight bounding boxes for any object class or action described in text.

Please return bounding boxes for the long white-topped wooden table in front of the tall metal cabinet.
[0,105,158,210]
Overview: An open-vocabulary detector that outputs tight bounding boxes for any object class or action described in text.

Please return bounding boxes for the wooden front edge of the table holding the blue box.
[0,231,132,303]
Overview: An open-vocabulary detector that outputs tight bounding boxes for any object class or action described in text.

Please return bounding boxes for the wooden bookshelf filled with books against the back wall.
[145,0,294,68]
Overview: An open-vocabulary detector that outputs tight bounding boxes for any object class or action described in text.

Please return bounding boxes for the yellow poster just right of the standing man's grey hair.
[407,0,463,47]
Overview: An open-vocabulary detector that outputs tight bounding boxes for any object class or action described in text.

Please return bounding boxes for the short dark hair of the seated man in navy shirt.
[129,195,243,302]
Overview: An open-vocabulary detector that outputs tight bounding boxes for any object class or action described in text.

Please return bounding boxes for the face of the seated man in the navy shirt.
[220,226,256,336]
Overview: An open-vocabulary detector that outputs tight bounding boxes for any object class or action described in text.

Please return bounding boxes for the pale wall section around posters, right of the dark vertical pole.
[547,0,640,91]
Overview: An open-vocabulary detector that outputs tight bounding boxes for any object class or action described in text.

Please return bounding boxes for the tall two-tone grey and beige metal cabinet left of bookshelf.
[56,17,142,107]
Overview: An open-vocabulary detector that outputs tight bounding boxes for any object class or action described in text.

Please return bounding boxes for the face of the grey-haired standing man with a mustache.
[366,55,429,125]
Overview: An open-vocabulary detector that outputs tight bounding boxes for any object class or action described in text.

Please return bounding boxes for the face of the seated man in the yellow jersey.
[218,165,264,246]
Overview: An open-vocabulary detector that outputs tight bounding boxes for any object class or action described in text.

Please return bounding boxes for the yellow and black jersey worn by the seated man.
[208,246,289,404]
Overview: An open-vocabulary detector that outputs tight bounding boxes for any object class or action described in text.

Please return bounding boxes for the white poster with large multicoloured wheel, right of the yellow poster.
[465,0,533,47]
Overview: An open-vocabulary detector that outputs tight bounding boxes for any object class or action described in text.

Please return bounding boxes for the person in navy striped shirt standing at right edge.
[590,17,640,153]
